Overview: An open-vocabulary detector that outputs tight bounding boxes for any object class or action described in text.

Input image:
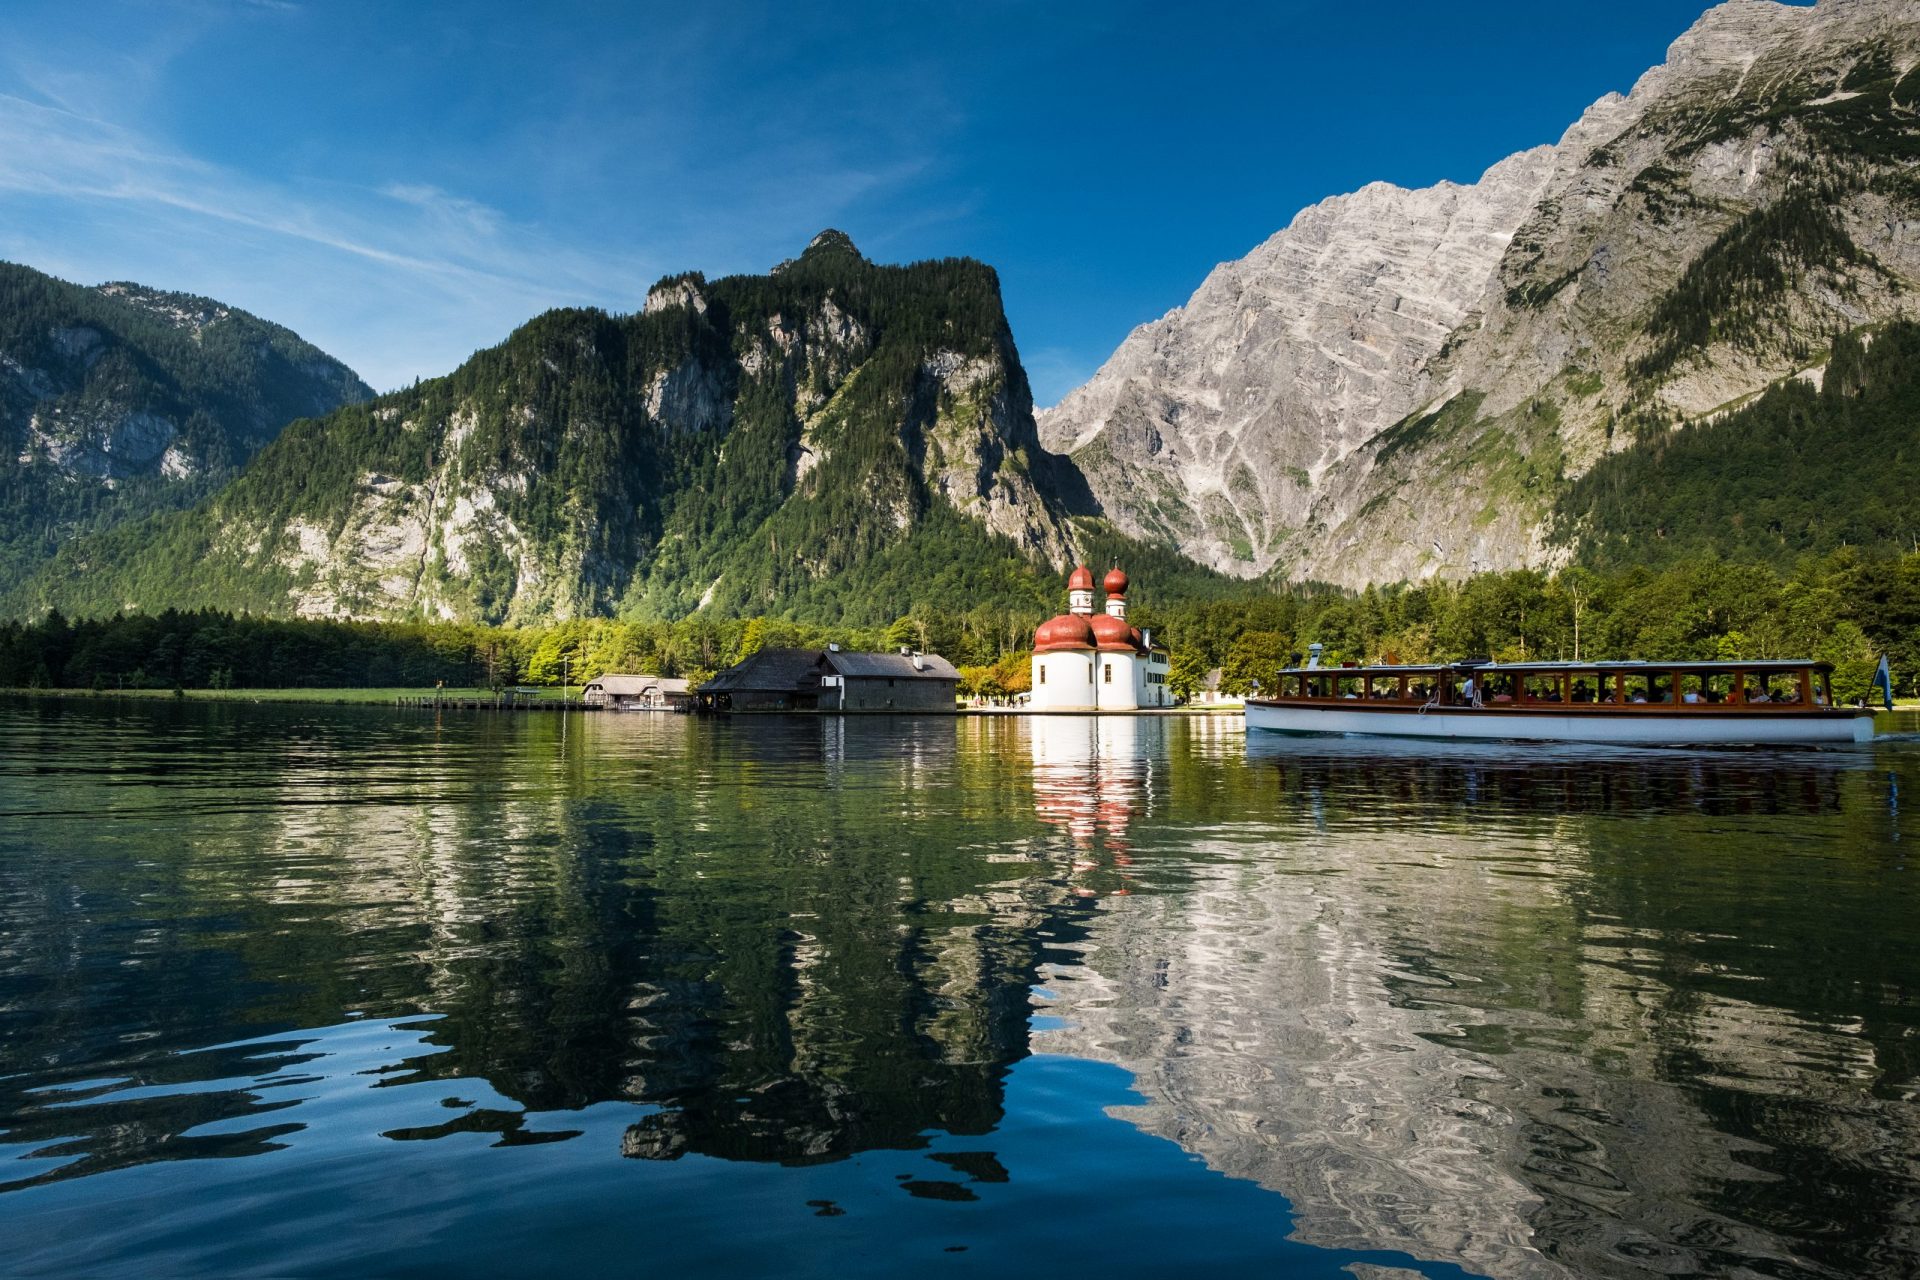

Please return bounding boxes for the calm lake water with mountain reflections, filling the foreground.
[0,702,1920,1278]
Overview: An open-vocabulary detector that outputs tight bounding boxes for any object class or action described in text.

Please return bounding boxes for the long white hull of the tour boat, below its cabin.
[1246,700,1874,747]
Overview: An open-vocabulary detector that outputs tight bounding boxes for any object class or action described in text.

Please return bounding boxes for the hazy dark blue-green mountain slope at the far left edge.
[0,263,372,591]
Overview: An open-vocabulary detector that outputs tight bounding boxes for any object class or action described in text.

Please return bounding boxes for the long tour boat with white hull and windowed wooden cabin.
[1246,658,1874,747]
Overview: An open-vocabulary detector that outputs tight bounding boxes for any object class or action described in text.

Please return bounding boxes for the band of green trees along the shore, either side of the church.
[0,549,1920,700]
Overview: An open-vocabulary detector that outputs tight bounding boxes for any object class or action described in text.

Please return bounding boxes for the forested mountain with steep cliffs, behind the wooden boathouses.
[12,230,1144,622]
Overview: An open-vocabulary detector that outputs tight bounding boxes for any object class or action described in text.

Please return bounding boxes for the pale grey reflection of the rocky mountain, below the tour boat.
[1041,739,1920,1276]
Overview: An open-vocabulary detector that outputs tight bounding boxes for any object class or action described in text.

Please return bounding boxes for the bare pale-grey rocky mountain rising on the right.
[1039,0,1920,587]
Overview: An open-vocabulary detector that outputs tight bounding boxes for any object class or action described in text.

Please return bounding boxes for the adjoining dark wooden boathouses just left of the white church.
[695,649,960,712]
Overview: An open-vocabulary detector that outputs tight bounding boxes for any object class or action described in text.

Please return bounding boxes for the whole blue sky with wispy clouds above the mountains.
[0,0,1766,403]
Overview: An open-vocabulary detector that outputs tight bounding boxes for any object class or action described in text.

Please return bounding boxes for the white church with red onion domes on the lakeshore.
[1027,564,1173,712]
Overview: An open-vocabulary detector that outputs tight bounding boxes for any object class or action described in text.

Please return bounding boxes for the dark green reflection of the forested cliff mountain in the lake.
[10,716,1081,1173]
